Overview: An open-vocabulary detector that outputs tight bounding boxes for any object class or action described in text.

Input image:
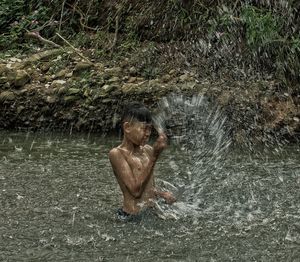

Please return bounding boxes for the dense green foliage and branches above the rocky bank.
[0,0,300,82]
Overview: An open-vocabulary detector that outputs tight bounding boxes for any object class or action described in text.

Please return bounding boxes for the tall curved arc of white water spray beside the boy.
[154,94,231,217]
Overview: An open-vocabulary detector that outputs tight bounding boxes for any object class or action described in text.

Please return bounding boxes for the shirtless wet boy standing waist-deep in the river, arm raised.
[109,102,176,220]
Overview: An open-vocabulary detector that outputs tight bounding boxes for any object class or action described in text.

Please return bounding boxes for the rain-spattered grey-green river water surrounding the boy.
[0,131,300,261]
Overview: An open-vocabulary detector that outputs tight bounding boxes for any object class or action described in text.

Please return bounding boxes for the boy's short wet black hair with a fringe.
[121,102,152,124]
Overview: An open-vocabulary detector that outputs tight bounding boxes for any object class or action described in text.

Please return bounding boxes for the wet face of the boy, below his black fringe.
[124,120,152,146]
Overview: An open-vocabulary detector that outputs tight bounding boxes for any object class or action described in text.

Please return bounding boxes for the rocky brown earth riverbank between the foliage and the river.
[0,46,300,144]
